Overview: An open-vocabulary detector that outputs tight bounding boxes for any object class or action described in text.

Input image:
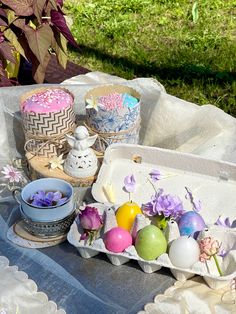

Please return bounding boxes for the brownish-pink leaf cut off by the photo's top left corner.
[1,0,34,16]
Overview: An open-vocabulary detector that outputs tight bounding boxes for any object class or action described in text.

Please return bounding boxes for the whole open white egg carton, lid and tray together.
[67,144,236,289]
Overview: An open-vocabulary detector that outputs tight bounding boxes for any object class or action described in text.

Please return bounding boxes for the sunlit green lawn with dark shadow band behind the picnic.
[65,0,236,117]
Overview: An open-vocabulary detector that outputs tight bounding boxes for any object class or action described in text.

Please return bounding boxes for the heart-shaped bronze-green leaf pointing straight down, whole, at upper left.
[25,24,53,65]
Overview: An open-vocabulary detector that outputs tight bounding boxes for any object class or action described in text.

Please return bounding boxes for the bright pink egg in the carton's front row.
[103,227,132,253]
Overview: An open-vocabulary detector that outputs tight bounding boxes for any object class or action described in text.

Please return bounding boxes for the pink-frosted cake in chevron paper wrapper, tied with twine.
[20,87,75,157]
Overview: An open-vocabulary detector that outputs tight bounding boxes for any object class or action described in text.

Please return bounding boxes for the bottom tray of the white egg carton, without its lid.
[67,203,236,289]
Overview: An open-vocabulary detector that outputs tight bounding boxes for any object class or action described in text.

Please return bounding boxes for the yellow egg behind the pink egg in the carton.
[116,201,142,231]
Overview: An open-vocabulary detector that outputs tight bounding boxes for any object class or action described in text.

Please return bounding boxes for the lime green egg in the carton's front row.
[135,225,167,261]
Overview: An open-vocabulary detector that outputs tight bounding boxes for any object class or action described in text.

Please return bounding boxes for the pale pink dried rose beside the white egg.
[199,237,220,262]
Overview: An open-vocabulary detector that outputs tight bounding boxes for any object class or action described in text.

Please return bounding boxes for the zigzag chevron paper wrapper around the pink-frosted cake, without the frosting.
[22,106,75,158]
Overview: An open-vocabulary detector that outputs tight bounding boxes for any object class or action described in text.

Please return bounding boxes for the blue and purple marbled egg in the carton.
[178,211,206,236]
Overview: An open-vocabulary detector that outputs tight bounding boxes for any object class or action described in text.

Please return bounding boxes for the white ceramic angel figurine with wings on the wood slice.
[64,126,98,178]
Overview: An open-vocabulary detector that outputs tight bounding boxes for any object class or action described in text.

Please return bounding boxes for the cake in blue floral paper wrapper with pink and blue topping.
[85,85,140,152]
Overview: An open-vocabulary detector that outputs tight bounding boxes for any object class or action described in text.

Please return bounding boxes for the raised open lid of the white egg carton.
[92,144,236,224]
